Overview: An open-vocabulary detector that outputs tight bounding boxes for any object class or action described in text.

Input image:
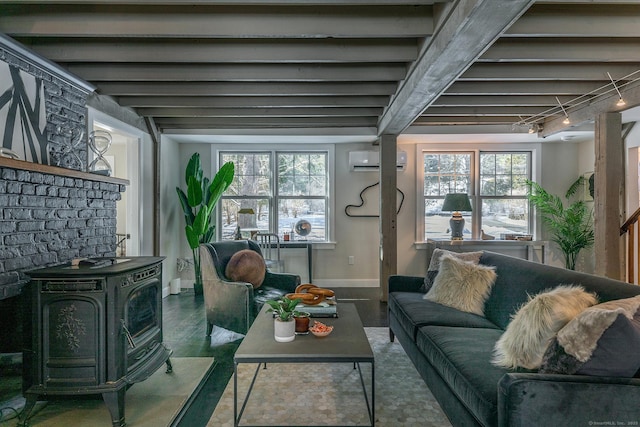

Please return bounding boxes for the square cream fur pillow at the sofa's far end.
[424,255,496,316]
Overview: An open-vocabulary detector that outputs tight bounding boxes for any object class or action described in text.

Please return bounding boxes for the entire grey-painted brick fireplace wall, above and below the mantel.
[0,36,126,353]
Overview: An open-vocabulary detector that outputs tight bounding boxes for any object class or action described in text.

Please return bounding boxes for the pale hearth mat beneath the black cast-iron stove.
[21,357,214,427]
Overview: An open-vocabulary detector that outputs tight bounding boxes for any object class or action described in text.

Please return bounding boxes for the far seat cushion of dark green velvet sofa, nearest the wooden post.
[388,292,497,339]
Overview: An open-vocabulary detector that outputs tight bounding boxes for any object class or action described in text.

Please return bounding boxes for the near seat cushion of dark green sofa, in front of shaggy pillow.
[416,326,507,426]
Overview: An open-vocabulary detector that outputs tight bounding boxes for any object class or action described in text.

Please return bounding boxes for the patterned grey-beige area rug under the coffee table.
[207,328,451,427]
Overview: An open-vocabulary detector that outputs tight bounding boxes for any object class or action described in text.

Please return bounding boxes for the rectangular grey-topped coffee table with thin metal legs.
[233,303,375,427]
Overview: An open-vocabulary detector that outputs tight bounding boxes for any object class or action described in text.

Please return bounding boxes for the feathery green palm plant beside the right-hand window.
[527,177,595,270]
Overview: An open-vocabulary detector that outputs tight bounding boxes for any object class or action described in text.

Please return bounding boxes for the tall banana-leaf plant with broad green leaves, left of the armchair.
[176,153,235,295]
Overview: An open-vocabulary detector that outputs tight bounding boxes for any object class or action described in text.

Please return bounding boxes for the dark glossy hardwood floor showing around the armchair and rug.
[162,288,388,427]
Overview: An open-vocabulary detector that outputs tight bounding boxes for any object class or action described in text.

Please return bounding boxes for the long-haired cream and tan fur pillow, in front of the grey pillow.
[492,285,598,369]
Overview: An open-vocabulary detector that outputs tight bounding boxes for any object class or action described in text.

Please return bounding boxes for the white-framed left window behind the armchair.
[219,151,329,241]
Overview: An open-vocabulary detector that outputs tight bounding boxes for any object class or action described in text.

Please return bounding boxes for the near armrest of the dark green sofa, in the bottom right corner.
[498,373,640,427]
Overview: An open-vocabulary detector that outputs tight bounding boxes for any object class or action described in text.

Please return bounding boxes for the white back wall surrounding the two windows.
[160,137,593,287]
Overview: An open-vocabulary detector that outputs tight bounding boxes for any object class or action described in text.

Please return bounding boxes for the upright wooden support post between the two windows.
[380,135,398,302]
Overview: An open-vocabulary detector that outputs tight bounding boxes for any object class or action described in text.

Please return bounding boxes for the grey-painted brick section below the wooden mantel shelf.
[0,167,125,293]
